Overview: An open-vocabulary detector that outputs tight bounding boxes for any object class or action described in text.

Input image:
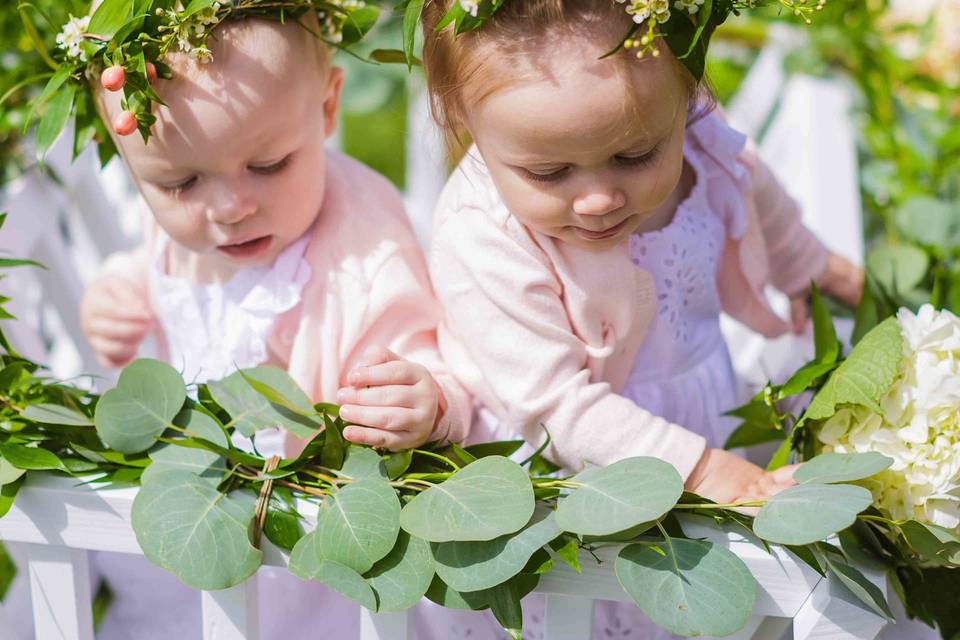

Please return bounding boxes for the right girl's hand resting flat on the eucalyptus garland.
[684,449,797,515]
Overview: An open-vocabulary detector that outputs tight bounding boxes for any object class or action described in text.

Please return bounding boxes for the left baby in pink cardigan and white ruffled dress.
[74,19,470,638]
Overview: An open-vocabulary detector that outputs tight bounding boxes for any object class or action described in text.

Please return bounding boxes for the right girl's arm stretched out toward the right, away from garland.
[747,151,864,330]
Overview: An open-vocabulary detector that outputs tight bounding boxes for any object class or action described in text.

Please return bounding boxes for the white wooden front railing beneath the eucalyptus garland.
[0,477,885,640]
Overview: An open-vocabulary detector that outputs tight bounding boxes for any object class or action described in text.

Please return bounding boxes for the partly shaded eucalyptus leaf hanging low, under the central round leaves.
[367,531,435,613]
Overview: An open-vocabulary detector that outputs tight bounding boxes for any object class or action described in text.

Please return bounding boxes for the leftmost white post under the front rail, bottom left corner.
[26,544,93,640]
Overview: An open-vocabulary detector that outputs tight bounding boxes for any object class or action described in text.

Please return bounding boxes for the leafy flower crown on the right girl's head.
[416,0,827,80]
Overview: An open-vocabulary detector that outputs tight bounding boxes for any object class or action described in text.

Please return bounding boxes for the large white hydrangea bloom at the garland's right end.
[818,305,960,529]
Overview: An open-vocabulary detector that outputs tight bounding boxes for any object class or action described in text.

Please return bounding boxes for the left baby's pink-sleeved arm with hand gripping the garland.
[326,205,472,450]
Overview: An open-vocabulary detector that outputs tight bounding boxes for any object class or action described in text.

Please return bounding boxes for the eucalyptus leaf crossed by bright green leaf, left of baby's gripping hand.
[207,366,322,438]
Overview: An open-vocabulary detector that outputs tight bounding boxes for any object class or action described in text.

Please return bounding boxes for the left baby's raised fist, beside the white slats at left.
[80,275,153,367]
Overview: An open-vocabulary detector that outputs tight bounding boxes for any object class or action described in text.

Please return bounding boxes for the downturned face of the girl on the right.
[465,38,688,250]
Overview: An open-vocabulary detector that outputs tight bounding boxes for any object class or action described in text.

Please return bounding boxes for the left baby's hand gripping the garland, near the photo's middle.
[337,347,441,450]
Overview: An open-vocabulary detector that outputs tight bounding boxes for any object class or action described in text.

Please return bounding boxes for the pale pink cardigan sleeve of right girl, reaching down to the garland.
[431,207,705,478]
